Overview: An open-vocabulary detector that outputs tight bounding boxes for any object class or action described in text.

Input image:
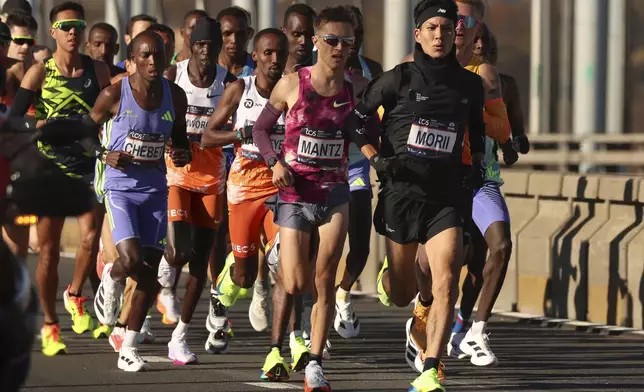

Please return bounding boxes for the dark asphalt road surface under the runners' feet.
[24,257,644,392]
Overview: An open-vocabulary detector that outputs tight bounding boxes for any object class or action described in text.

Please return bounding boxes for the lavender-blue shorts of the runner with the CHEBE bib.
[105,190,168,250]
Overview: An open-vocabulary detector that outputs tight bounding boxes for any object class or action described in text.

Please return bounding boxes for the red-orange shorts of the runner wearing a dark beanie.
[168,186,224,230]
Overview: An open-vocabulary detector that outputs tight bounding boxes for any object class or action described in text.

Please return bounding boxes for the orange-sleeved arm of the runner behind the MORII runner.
[479,63,511,145]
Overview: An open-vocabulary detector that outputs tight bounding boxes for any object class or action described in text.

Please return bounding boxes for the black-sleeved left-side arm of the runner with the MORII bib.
[344,69,399,159]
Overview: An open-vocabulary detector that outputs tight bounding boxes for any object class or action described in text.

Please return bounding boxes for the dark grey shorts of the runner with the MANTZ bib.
[266,184,351,233]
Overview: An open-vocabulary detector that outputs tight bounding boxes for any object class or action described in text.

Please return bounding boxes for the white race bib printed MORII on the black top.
[407,118,459,158]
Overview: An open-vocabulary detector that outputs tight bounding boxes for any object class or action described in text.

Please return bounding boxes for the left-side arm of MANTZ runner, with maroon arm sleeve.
[253,73,300,166]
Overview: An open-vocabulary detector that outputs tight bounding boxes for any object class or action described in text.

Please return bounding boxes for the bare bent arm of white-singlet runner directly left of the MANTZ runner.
[201,79,245,148]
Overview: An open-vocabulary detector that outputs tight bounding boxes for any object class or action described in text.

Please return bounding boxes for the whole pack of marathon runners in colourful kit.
[0,0,530,392]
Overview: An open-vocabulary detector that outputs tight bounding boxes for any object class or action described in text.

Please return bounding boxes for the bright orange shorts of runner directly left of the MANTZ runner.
[228,195,279,259]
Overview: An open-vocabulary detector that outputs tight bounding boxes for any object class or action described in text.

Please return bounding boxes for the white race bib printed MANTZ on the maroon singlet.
[297,127,344,169]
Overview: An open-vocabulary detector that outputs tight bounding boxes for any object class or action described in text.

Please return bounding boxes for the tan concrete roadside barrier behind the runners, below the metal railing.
[55,170,644,328]
